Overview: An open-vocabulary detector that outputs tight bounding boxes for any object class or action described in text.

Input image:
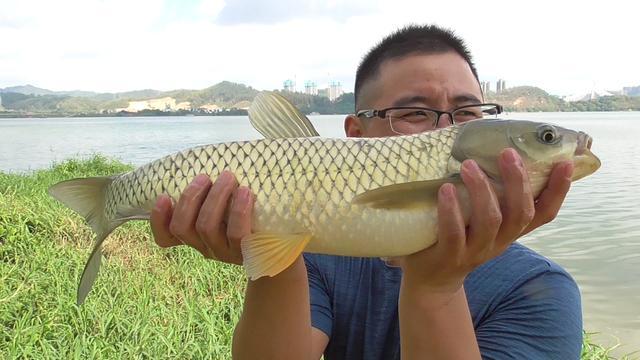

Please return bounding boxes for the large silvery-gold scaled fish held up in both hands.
[49,93,600,304]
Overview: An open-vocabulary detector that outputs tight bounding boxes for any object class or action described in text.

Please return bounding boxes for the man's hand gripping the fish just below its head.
[400,149,573,294]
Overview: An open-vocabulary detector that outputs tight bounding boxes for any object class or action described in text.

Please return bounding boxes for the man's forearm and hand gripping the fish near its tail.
[151,172,329,360]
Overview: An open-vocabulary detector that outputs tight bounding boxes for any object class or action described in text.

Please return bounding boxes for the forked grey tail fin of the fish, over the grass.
[49,177,124,305]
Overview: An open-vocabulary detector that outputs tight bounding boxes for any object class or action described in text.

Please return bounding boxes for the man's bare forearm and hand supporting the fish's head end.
[399,150,573,359]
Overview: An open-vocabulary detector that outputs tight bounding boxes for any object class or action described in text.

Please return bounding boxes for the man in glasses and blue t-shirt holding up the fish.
[151,26,582,359]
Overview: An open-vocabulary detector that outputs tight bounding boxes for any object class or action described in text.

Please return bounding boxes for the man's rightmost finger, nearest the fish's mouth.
[522,162,573,235]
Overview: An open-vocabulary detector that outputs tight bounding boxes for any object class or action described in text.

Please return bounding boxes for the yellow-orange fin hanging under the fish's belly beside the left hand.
[241,233,311,280]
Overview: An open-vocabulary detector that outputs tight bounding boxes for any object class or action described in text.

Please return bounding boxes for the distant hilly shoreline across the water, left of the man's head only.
[0,81,354,116]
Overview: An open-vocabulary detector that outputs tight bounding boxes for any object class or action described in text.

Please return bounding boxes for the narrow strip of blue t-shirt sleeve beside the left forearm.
[304,254,333,338]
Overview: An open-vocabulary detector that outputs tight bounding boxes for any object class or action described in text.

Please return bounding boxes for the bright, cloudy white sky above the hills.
[0,0,640,95]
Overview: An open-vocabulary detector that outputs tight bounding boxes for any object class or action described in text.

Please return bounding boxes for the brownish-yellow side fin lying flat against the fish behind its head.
[353,175,461,209]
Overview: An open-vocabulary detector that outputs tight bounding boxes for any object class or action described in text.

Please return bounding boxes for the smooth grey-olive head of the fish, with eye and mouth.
[452,119,600,196]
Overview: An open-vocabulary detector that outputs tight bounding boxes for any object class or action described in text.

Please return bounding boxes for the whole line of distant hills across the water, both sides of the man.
[0,81,640,117]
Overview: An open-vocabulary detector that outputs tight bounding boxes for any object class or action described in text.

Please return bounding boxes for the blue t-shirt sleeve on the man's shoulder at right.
[476,269,582,360]
